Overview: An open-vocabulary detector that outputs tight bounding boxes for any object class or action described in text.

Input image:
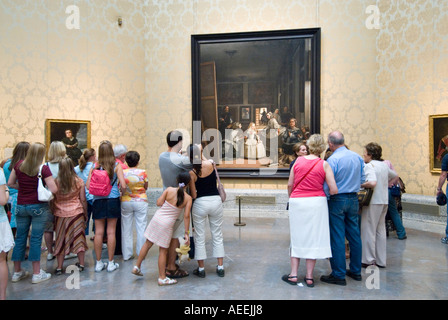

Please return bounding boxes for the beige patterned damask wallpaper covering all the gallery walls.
[0,0,448,195]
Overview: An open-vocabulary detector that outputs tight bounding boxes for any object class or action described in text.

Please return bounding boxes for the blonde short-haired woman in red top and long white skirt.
[282,134,338,287]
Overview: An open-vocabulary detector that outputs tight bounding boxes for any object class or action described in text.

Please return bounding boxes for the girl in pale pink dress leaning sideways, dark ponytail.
[132,172,193,286]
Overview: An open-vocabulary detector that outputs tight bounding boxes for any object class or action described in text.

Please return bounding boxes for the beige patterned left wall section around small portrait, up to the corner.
[0,0,147,166]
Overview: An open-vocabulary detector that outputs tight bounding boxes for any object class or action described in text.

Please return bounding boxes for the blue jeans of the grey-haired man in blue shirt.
[328,193,362,279]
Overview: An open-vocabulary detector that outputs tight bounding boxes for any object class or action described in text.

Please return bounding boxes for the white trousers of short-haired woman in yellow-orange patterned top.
[121,201,148,260]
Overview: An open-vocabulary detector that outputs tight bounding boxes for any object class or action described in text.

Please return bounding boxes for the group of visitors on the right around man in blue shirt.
[282,131,412,287]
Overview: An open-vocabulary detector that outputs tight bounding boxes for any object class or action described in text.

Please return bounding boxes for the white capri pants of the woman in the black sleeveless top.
[192,196,225,260]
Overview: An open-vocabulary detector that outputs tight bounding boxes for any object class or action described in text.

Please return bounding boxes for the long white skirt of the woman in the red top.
[289,197,331,259]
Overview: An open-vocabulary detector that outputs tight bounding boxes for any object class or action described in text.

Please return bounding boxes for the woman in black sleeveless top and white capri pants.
[188,145,225,278]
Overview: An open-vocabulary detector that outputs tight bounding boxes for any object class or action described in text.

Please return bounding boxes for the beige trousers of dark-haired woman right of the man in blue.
[361,204,388,267]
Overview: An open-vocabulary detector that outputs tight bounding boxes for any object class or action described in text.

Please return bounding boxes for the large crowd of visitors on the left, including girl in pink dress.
[0,131,225,299]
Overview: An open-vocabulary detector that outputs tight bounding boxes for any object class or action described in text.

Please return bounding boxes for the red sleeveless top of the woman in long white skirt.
[290,157,326,198]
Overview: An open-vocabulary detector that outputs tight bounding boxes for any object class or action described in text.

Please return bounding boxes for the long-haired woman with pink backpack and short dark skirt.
[86,141,126,272]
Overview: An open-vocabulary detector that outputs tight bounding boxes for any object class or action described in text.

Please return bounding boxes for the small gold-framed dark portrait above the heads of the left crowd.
[45,119,91,166]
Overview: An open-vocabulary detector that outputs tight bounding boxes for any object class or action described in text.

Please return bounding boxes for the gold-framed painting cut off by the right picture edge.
[429,114,448,173]
